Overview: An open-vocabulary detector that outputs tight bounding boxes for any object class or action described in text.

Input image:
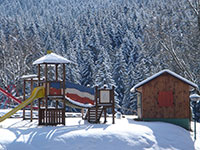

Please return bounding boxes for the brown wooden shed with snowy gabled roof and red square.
[131,69,198,130]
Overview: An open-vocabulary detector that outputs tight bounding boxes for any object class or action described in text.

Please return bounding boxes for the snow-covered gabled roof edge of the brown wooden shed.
[131,69,198,92]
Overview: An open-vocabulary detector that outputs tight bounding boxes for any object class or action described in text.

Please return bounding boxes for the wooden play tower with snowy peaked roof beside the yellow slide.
[33,52,71,125]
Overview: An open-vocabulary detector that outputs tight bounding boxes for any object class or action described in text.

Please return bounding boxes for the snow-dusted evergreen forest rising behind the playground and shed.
[0,0,200,114]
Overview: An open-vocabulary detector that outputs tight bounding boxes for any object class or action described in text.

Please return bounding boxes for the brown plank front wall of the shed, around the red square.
[141,73,190,118]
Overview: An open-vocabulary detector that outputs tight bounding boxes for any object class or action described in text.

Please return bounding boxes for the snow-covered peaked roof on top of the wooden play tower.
[33,53,73,65]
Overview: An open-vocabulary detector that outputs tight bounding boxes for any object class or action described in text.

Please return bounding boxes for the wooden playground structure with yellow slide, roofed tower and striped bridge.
[0,52,115,125]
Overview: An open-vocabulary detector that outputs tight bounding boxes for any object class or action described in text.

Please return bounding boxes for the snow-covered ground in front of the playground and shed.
[0,110,200,150]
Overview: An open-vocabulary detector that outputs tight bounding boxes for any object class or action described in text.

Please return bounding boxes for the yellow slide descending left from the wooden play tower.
[0,86,45,122]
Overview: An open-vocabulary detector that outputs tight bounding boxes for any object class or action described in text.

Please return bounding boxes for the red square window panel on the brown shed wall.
[158,91,173,107]
